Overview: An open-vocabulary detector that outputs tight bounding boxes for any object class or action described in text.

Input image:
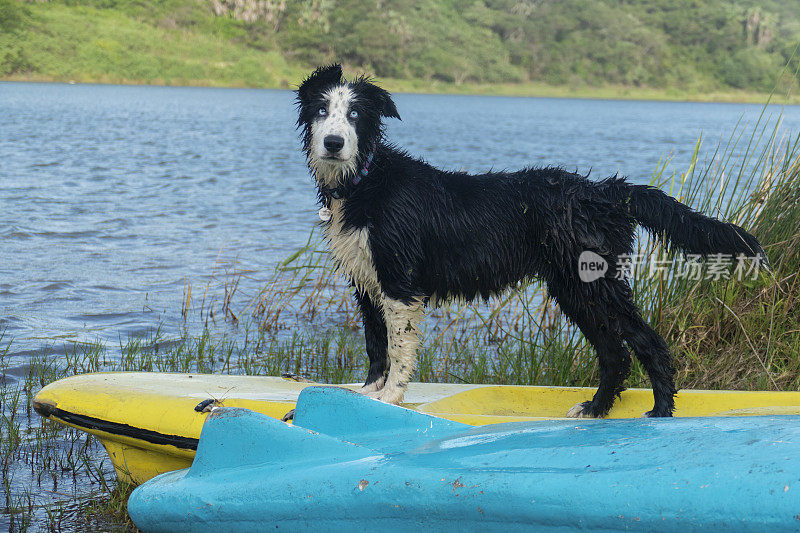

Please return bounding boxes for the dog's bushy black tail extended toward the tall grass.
[628,185,769,268]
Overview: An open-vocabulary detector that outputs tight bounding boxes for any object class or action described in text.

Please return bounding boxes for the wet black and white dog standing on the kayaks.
[297,65,766,417]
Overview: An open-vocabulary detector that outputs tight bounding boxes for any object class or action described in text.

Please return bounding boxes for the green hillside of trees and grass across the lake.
[0,0,800,92]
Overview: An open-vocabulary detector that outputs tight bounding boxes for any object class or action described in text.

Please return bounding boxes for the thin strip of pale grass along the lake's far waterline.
[0,74,800,105]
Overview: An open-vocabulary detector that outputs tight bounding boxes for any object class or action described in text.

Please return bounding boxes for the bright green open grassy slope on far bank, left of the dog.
[4,3,300,87]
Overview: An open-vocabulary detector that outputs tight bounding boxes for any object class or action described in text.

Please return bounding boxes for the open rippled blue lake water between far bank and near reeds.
[0,83,800,366]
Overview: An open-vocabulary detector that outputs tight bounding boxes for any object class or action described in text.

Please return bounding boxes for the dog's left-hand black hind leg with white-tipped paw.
[554,280,631,418]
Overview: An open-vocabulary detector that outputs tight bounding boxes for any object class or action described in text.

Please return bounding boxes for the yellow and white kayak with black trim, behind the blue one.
[33,372,800,483]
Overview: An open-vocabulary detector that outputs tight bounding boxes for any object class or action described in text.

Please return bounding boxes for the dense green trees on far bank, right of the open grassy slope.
[266,0,800,90]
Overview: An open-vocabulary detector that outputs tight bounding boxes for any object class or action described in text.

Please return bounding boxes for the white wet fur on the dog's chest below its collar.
[325,200,381,301]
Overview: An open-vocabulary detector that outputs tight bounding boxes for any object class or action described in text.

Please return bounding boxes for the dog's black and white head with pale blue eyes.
[297,64,400,187]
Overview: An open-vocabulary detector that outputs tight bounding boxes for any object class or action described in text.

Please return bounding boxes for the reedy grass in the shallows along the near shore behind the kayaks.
[0,115,800,531]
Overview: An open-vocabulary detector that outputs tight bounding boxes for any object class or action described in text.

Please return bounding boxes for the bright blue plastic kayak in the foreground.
[128,387,800,533]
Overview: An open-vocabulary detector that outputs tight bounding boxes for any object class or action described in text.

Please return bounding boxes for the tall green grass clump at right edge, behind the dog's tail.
[660,120,800,390]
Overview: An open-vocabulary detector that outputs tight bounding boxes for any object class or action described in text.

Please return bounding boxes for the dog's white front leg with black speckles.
[368,297,422,404]
